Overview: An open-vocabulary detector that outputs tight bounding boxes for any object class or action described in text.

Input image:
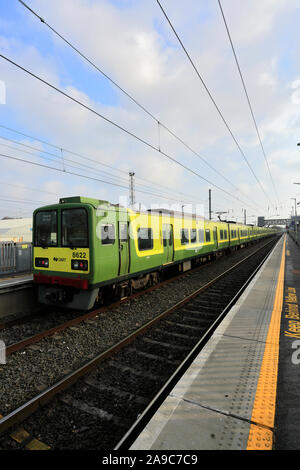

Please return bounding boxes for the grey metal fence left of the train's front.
[0,241,32,276]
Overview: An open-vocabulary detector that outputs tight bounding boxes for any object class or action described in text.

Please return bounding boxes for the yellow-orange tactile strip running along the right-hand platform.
[247,240,286,450]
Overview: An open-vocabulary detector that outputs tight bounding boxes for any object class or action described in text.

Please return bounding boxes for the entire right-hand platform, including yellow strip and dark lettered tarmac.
[130,235,300,450]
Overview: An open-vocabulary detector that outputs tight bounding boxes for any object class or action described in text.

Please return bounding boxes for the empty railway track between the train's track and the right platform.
[0,234,277,449]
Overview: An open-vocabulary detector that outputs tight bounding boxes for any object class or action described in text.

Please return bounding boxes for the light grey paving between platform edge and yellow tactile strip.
[131,238,283,450]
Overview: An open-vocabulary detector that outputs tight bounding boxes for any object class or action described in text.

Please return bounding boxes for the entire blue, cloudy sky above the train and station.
[0,0,300,223]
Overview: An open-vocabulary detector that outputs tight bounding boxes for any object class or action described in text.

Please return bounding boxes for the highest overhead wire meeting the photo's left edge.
[0,54,264,212]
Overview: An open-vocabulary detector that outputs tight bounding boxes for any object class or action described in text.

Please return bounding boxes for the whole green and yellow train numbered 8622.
[33,197,274,310]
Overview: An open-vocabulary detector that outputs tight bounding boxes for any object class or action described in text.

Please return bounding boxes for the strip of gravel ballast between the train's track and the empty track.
[0,240,276,415]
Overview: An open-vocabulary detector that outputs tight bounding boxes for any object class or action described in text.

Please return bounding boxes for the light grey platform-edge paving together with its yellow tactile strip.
[131,235,286,450]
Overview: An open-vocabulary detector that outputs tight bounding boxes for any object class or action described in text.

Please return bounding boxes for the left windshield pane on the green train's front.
[34,211,57,246]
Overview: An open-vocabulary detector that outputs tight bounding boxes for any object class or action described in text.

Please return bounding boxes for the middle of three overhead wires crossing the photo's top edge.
[155,0,273,208]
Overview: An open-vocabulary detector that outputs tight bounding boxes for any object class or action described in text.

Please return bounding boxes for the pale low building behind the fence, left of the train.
[0,217,32,243]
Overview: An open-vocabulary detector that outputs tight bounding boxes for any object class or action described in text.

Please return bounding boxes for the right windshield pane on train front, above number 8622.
[62,209,89,248]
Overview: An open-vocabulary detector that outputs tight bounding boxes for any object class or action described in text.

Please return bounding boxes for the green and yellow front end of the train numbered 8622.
[33,200,98,310]
